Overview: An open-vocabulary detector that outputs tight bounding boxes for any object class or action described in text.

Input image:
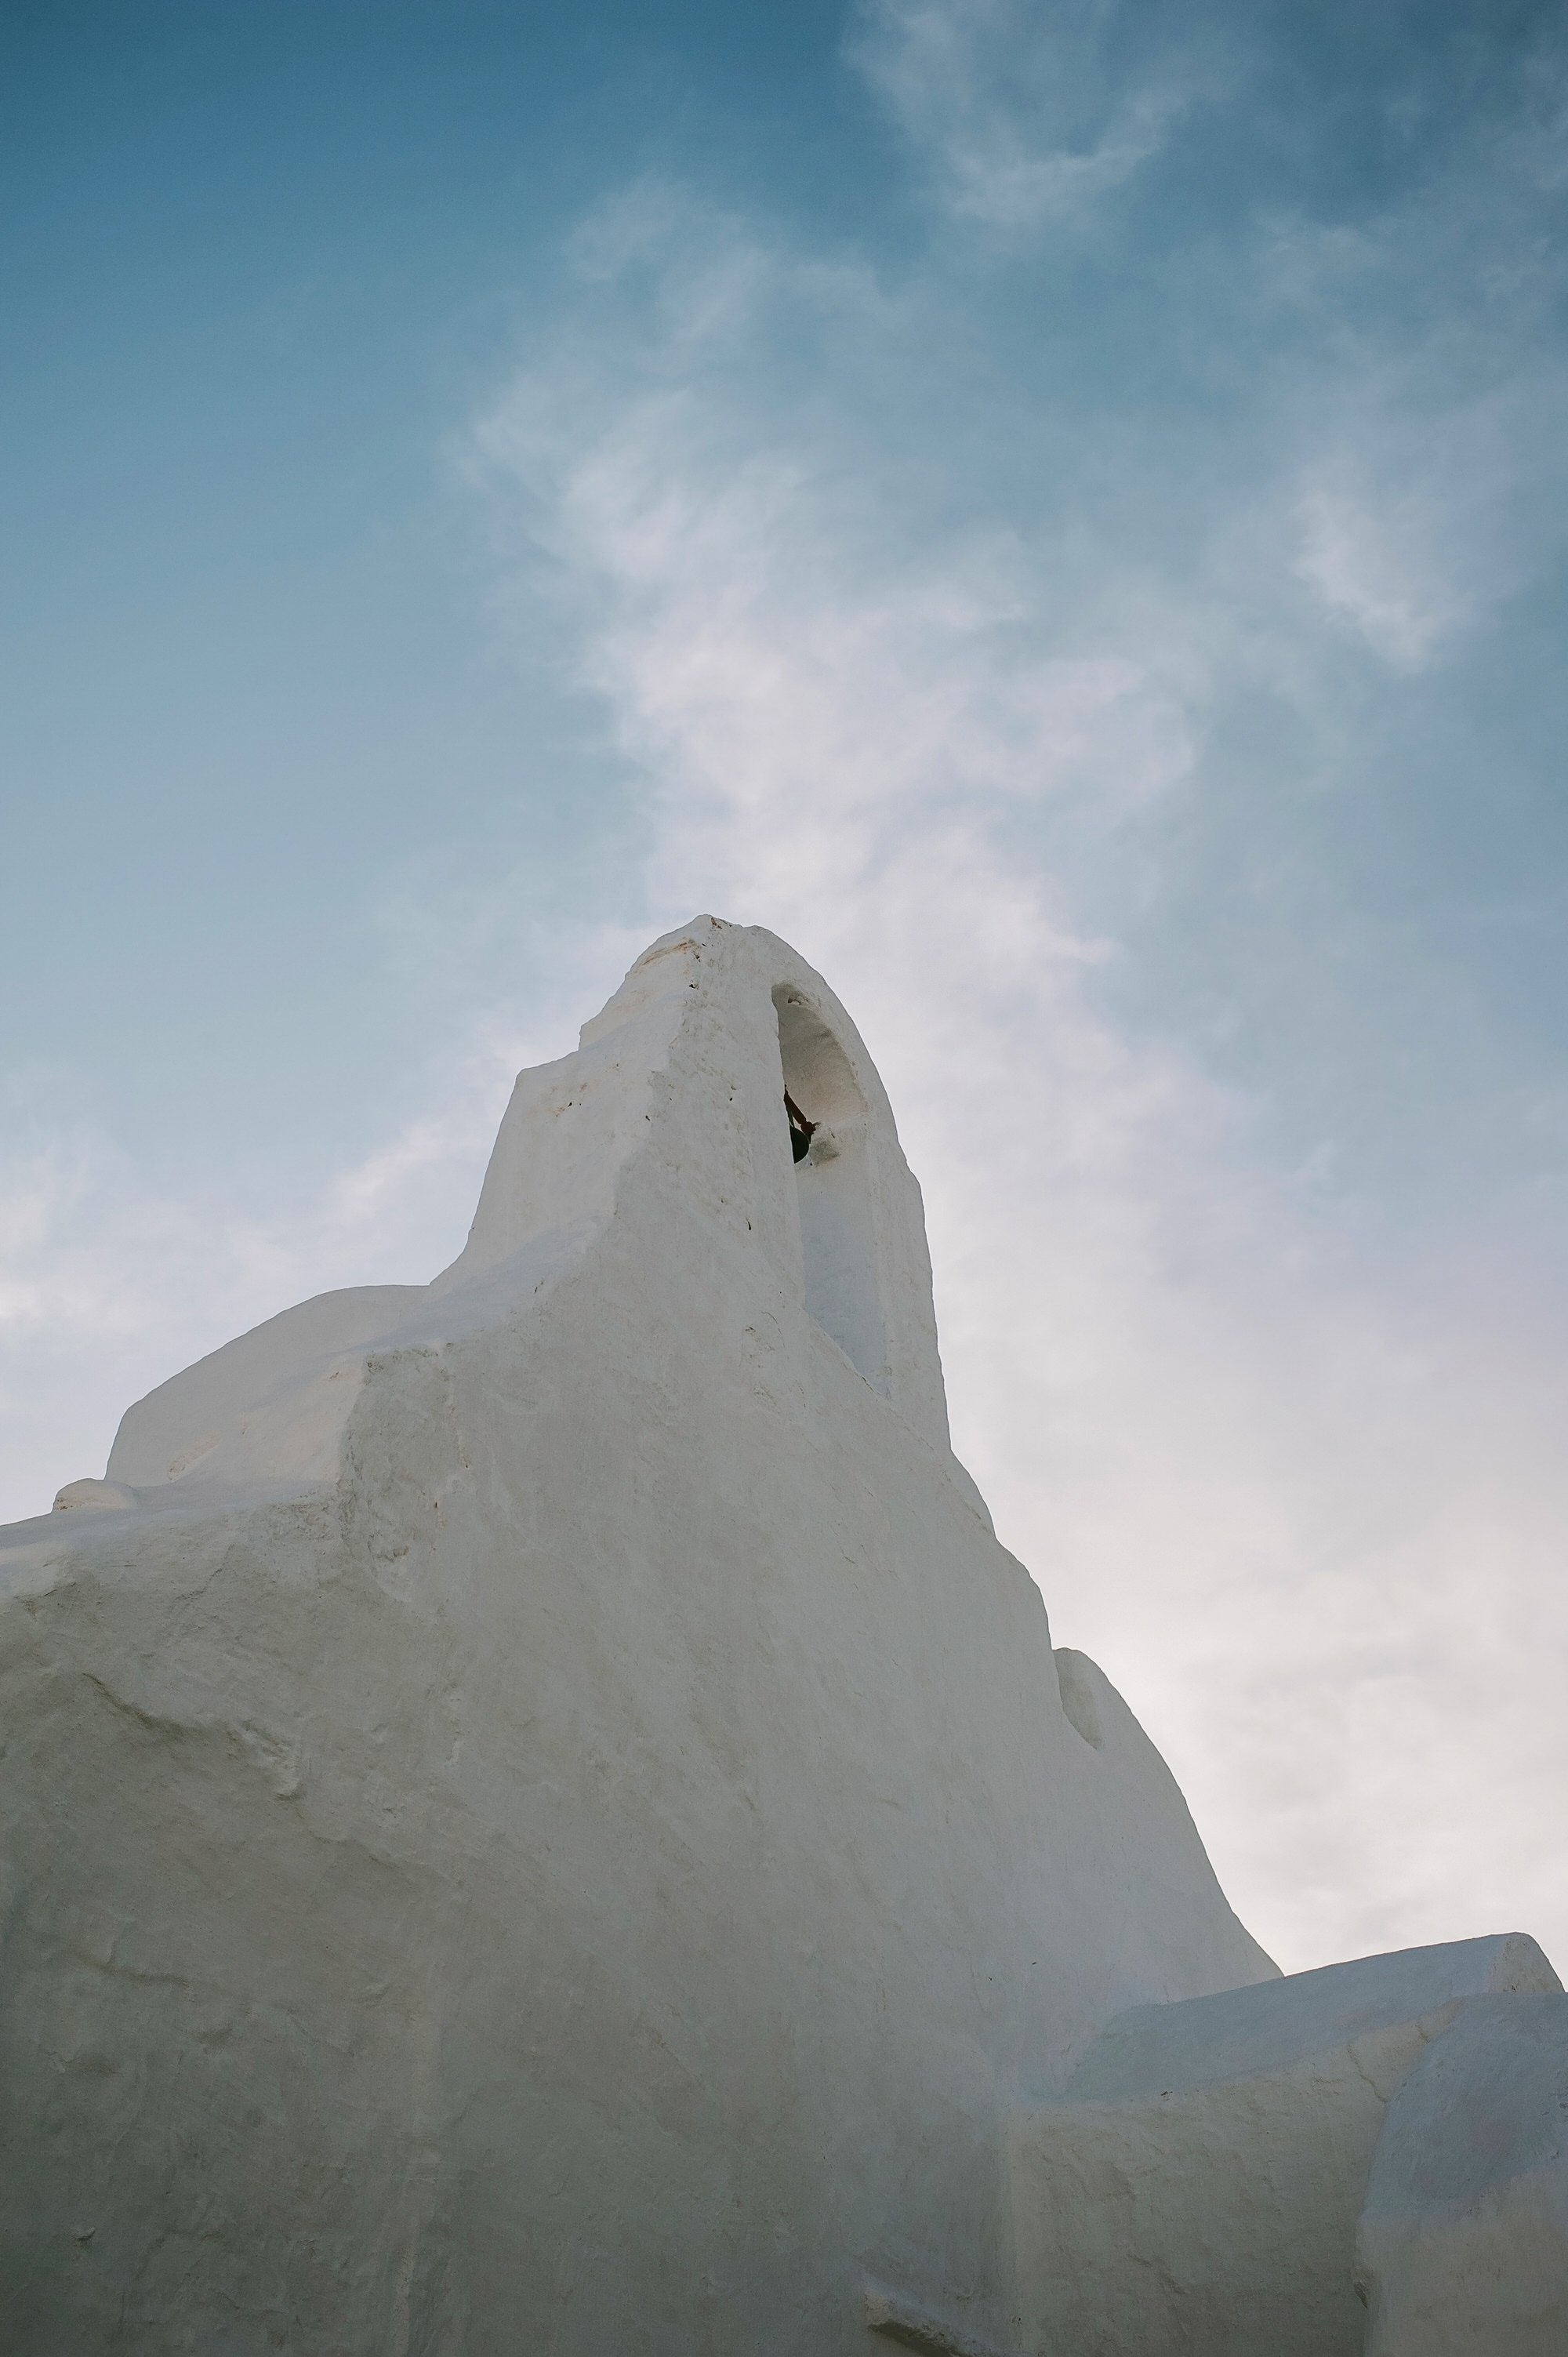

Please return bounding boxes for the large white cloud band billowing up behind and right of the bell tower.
[462,202,1568,1966]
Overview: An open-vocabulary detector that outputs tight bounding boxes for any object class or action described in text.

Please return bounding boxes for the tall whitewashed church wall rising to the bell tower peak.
[0,919,1273,2357]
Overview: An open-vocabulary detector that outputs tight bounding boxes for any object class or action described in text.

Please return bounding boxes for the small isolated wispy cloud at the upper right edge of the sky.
[1254,176,1568,677]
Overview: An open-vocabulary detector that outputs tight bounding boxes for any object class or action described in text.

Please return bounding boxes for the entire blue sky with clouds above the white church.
[0,0,1568,1963]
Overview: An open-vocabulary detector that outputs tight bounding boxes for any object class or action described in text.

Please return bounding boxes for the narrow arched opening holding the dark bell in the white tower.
[773,983,889,1393]
